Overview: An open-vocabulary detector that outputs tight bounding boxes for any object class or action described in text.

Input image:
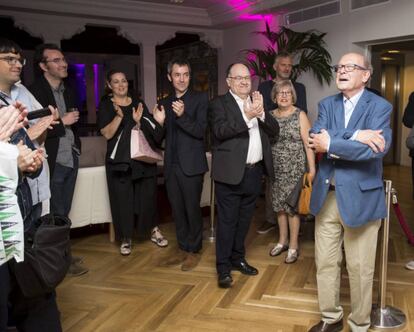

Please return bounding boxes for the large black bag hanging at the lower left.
[12,214,72,298]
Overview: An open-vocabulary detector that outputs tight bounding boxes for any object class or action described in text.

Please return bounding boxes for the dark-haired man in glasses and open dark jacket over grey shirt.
[30,44,88,276]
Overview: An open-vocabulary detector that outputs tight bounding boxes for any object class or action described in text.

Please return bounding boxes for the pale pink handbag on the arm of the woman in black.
[131,125,163,164]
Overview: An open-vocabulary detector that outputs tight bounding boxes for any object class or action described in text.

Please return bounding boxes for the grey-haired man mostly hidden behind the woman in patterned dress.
[256,52,308,234]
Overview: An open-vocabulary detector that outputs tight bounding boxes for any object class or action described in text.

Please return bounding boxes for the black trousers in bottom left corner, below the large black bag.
[0,262,62,332]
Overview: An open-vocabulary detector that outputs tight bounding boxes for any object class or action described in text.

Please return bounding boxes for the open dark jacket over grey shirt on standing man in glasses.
[29,76,81,177]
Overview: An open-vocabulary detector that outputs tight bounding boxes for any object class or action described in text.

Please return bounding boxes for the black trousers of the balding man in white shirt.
[215,163,263,273]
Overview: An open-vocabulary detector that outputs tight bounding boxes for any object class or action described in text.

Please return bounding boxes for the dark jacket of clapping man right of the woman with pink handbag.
[160,90,208,178]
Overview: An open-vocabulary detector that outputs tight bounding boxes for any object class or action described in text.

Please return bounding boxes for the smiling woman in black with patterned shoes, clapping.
[98,71,168,255]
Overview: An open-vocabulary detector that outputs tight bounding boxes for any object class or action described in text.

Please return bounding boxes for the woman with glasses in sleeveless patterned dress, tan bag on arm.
[269,80,315,264]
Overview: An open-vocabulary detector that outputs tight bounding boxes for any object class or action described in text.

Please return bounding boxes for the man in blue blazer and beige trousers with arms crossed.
[309,53,392,332]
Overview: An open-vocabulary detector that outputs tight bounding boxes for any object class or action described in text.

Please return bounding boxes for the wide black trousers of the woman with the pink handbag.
[106,165,157,240]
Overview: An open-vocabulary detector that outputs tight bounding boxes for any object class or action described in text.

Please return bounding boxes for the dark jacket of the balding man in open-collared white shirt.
[209,92,279,184]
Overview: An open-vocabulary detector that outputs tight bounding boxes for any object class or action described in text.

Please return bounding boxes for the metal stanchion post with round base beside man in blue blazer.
[371,180,406,329]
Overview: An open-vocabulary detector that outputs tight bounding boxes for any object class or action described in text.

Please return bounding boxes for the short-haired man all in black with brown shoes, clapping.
[160,59,208,271]
